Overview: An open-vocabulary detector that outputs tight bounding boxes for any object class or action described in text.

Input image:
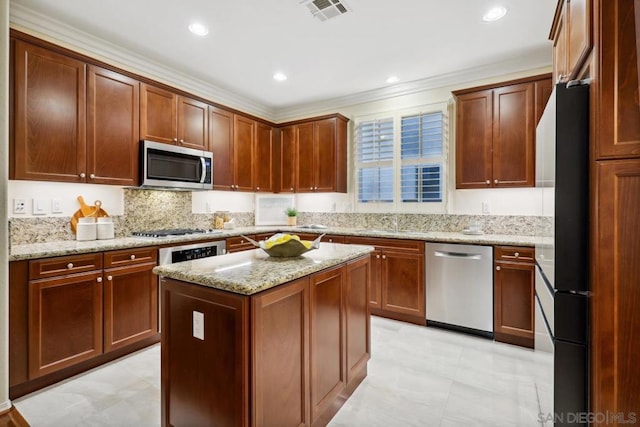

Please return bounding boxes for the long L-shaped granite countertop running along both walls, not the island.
[9,226,539,261]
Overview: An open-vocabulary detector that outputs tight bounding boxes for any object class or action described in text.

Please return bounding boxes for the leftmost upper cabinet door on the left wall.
[11,40,86,182]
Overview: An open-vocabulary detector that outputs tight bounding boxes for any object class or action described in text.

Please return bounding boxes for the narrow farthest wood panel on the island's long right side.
[345,257,371,388]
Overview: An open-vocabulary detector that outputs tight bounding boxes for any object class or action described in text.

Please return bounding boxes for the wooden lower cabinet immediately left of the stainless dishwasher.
[345,236,426,325]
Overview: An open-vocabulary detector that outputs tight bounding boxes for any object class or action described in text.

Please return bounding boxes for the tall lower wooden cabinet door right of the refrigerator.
[590,159,640,414]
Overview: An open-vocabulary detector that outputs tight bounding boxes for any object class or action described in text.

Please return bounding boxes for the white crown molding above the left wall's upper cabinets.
[9,3,275,121]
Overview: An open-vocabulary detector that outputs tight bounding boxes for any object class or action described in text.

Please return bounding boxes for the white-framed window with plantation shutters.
[355,107,448,211]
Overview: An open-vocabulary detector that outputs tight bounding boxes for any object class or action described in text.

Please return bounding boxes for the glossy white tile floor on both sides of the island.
[13,317,546,427]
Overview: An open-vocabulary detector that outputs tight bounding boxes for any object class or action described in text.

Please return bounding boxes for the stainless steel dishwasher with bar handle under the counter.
[425,243,493,337]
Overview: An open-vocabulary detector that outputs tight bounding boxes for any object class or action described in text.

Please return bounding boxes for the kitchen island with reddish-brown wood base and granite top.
[154,243,373,426]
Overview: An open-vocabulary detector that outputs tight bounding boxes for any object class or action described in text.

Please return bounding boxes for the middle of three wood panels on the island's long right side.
[309,267,346,423]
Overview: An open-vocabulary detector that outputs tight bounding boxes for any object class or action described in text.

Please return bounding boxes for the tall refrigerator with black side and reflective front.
[535,81,589,426]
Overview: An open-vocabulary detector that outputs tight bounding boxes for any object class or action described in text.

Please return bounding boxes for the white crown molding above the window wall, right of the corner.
[275,49,551,122]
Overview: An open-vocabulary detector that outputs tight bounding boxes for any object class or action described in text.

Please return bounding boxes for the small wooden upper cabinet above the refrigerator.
[549,0,593,82]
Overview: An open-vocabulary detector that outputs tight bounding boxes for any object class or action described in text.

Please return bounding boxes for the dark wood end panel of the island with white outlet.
[161,278,249,427]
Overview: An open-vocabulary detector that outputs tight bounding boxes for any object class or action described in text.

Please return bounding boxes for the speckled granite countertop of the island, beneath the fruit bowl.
[153,243,373,295]
